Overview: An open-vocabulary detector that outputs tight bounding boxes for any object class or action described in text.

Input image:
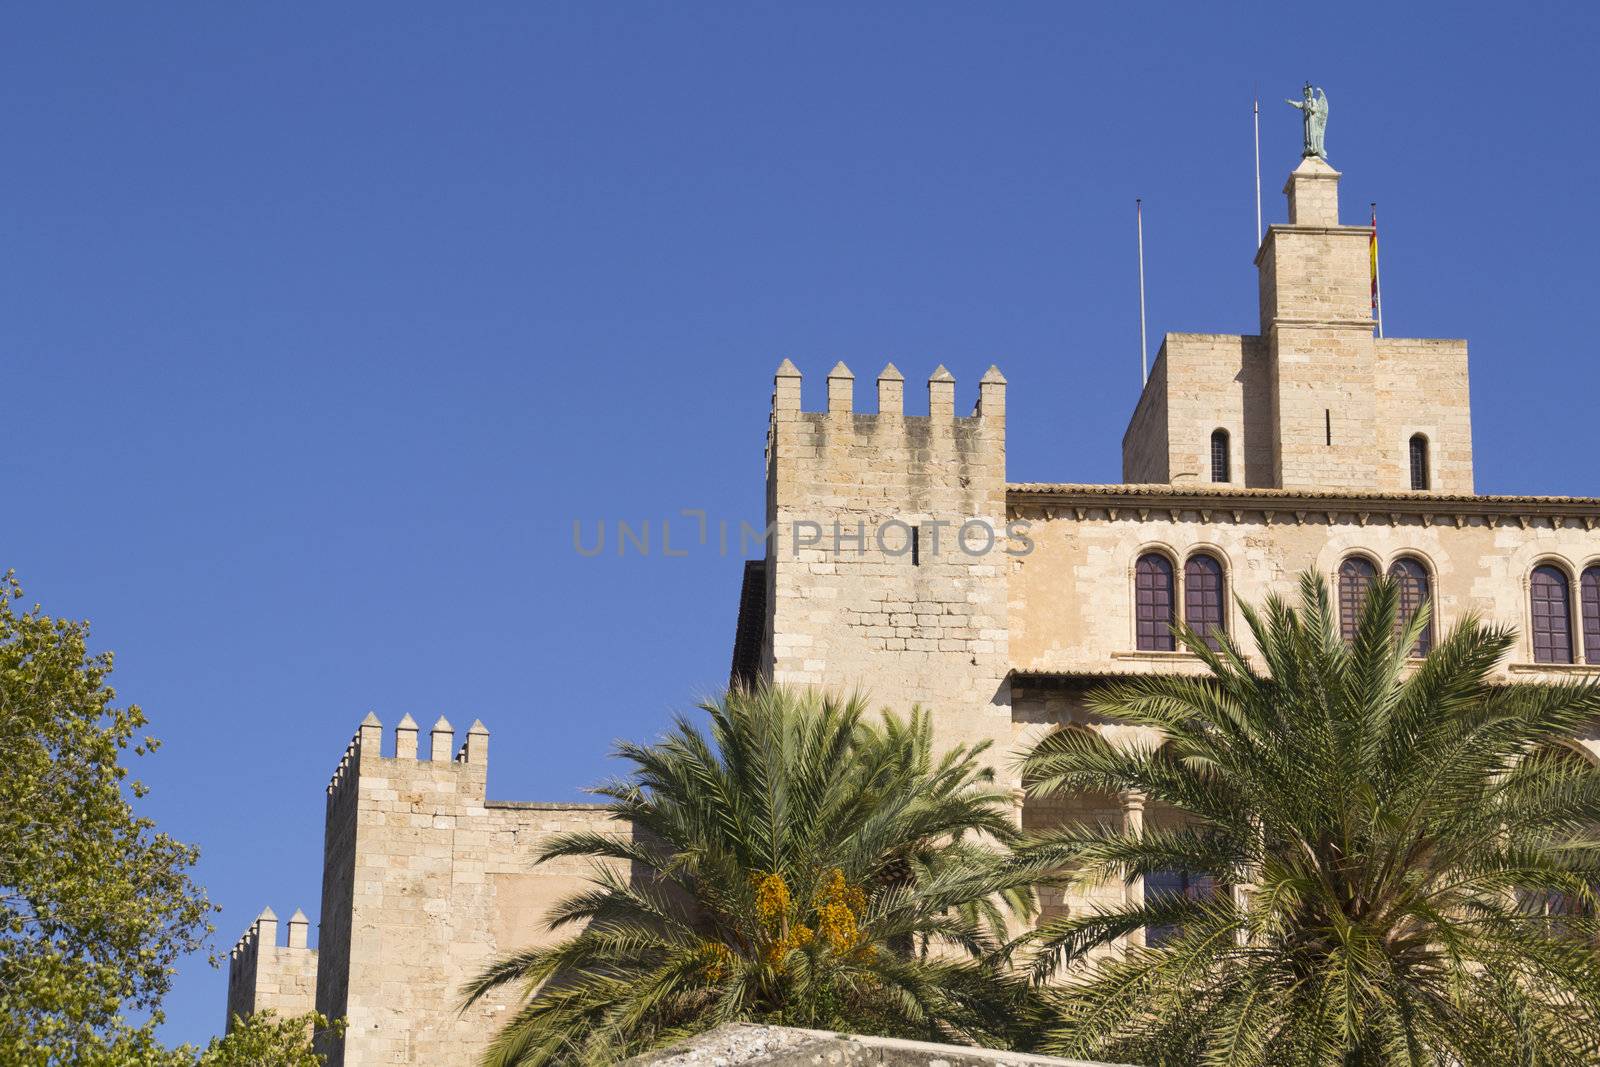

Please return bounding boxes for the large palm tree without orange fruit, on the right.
[1026,576,1600,1067]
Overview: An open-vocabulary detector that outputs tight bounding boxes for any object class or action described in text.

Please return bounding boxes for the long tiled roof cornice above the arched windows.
[1005,482,1600,530]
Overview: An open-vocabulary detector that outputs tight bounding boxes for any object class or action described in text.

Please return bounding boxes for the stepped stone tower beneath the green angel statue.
[1123,157,1474,493]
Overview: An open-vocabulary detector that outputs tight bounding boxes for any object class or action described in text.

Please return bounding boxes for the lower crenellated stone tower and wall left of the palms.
[305,715,629,1067]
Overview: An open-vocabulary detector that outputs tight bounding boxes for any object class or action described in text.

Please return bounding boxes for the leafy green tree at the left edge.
[0,573,211,1067]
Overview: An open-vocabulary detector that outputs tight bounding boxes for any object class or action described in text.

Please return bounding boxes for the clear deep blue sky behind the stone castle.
[0,2,1600,1040]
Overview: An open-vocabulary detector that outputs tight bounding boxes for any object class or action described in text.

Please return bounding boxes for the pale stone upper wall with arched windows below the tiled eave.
[1010,486,1600,678]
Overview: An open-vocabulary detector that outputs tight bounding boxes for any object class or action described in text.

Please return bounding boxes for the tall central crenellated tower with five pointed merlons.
[766,360,1010,790]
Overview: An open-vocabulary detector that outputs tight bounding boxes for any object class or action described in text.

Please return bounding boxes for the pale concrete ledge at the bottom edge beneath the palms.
[626,1022,1117,1067]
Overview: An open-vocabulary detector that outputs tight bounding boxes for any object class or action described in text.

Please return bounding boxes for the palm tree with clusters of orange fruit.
[466,686,1032,1065]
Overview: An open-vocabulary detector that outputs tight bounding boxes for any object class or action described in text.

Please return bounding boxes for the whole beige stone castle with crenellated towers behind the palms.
[229,158,1600,1067]
